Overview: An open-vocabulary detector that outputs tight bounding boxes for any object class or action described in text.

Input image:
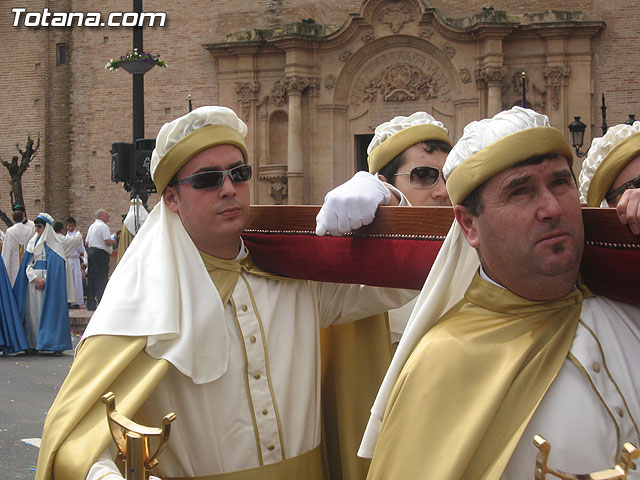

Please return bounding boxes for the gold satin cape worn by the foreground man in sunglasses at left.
[36,249,391,480]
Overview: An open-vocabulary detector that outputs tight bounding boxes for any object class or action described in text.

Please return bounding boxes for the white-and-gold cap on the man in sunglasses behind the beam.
[367,112,453,173]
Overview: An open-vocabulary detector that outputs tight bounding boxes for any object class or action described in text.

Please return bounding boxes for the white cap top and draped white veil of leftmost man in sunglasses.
[83,107,246,384]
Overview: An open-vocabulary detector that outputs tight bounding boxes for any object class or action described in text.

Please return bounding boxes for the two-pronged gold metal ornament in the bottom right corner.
[533,435,640,480]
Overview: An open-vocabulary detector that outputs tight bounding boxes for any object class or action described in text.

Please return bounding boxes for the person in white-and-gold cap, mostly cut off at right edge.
[579,122,640,235]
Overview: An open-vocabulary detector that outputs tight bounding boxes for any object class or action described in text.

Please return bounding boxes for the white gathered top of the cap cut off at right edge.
[578,121,640,207]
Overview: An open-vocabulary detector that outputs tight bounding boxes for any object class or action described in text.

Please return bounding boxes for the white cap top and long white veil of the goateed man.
[358,107,570,458]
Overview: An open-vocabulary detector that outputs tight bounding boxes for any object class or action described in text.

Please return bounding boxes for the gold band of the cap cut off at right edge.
[587,132,640,207]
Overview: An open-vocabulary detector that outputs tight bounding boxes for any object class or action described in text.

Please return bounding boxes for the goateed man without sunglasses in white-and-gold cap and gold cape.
[360,107,640,480]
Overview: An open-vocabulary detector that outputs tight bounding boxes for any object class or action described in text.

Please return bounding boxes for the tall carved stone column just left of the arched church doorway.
[287,77,309,205]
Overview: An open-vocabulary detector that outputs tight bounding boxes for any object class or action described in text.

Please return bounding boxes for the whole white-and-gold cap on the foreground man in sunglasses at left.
[150,106,248,195]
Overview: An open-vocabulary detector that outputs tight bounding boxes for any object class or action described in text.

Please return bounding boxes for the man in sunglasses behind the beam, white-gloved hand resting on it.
[316,112,453,346]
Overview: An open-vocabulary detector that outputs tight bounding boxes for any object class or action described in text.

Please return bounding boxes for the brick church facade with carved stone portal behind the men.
[0,0,640,232]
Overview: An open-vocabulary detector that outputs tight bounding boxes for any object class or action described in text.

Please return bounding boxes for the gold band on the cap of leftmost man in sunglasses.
[153,125,249,195]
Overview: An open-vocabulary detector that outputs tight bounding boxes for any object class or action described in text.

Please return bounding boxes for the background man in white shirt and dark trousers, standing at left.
[86,208,116,310]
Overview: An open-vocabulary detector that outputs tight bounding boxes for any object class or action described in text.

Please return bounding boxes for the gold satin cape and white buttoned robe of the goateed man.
[368,277,640,480]
